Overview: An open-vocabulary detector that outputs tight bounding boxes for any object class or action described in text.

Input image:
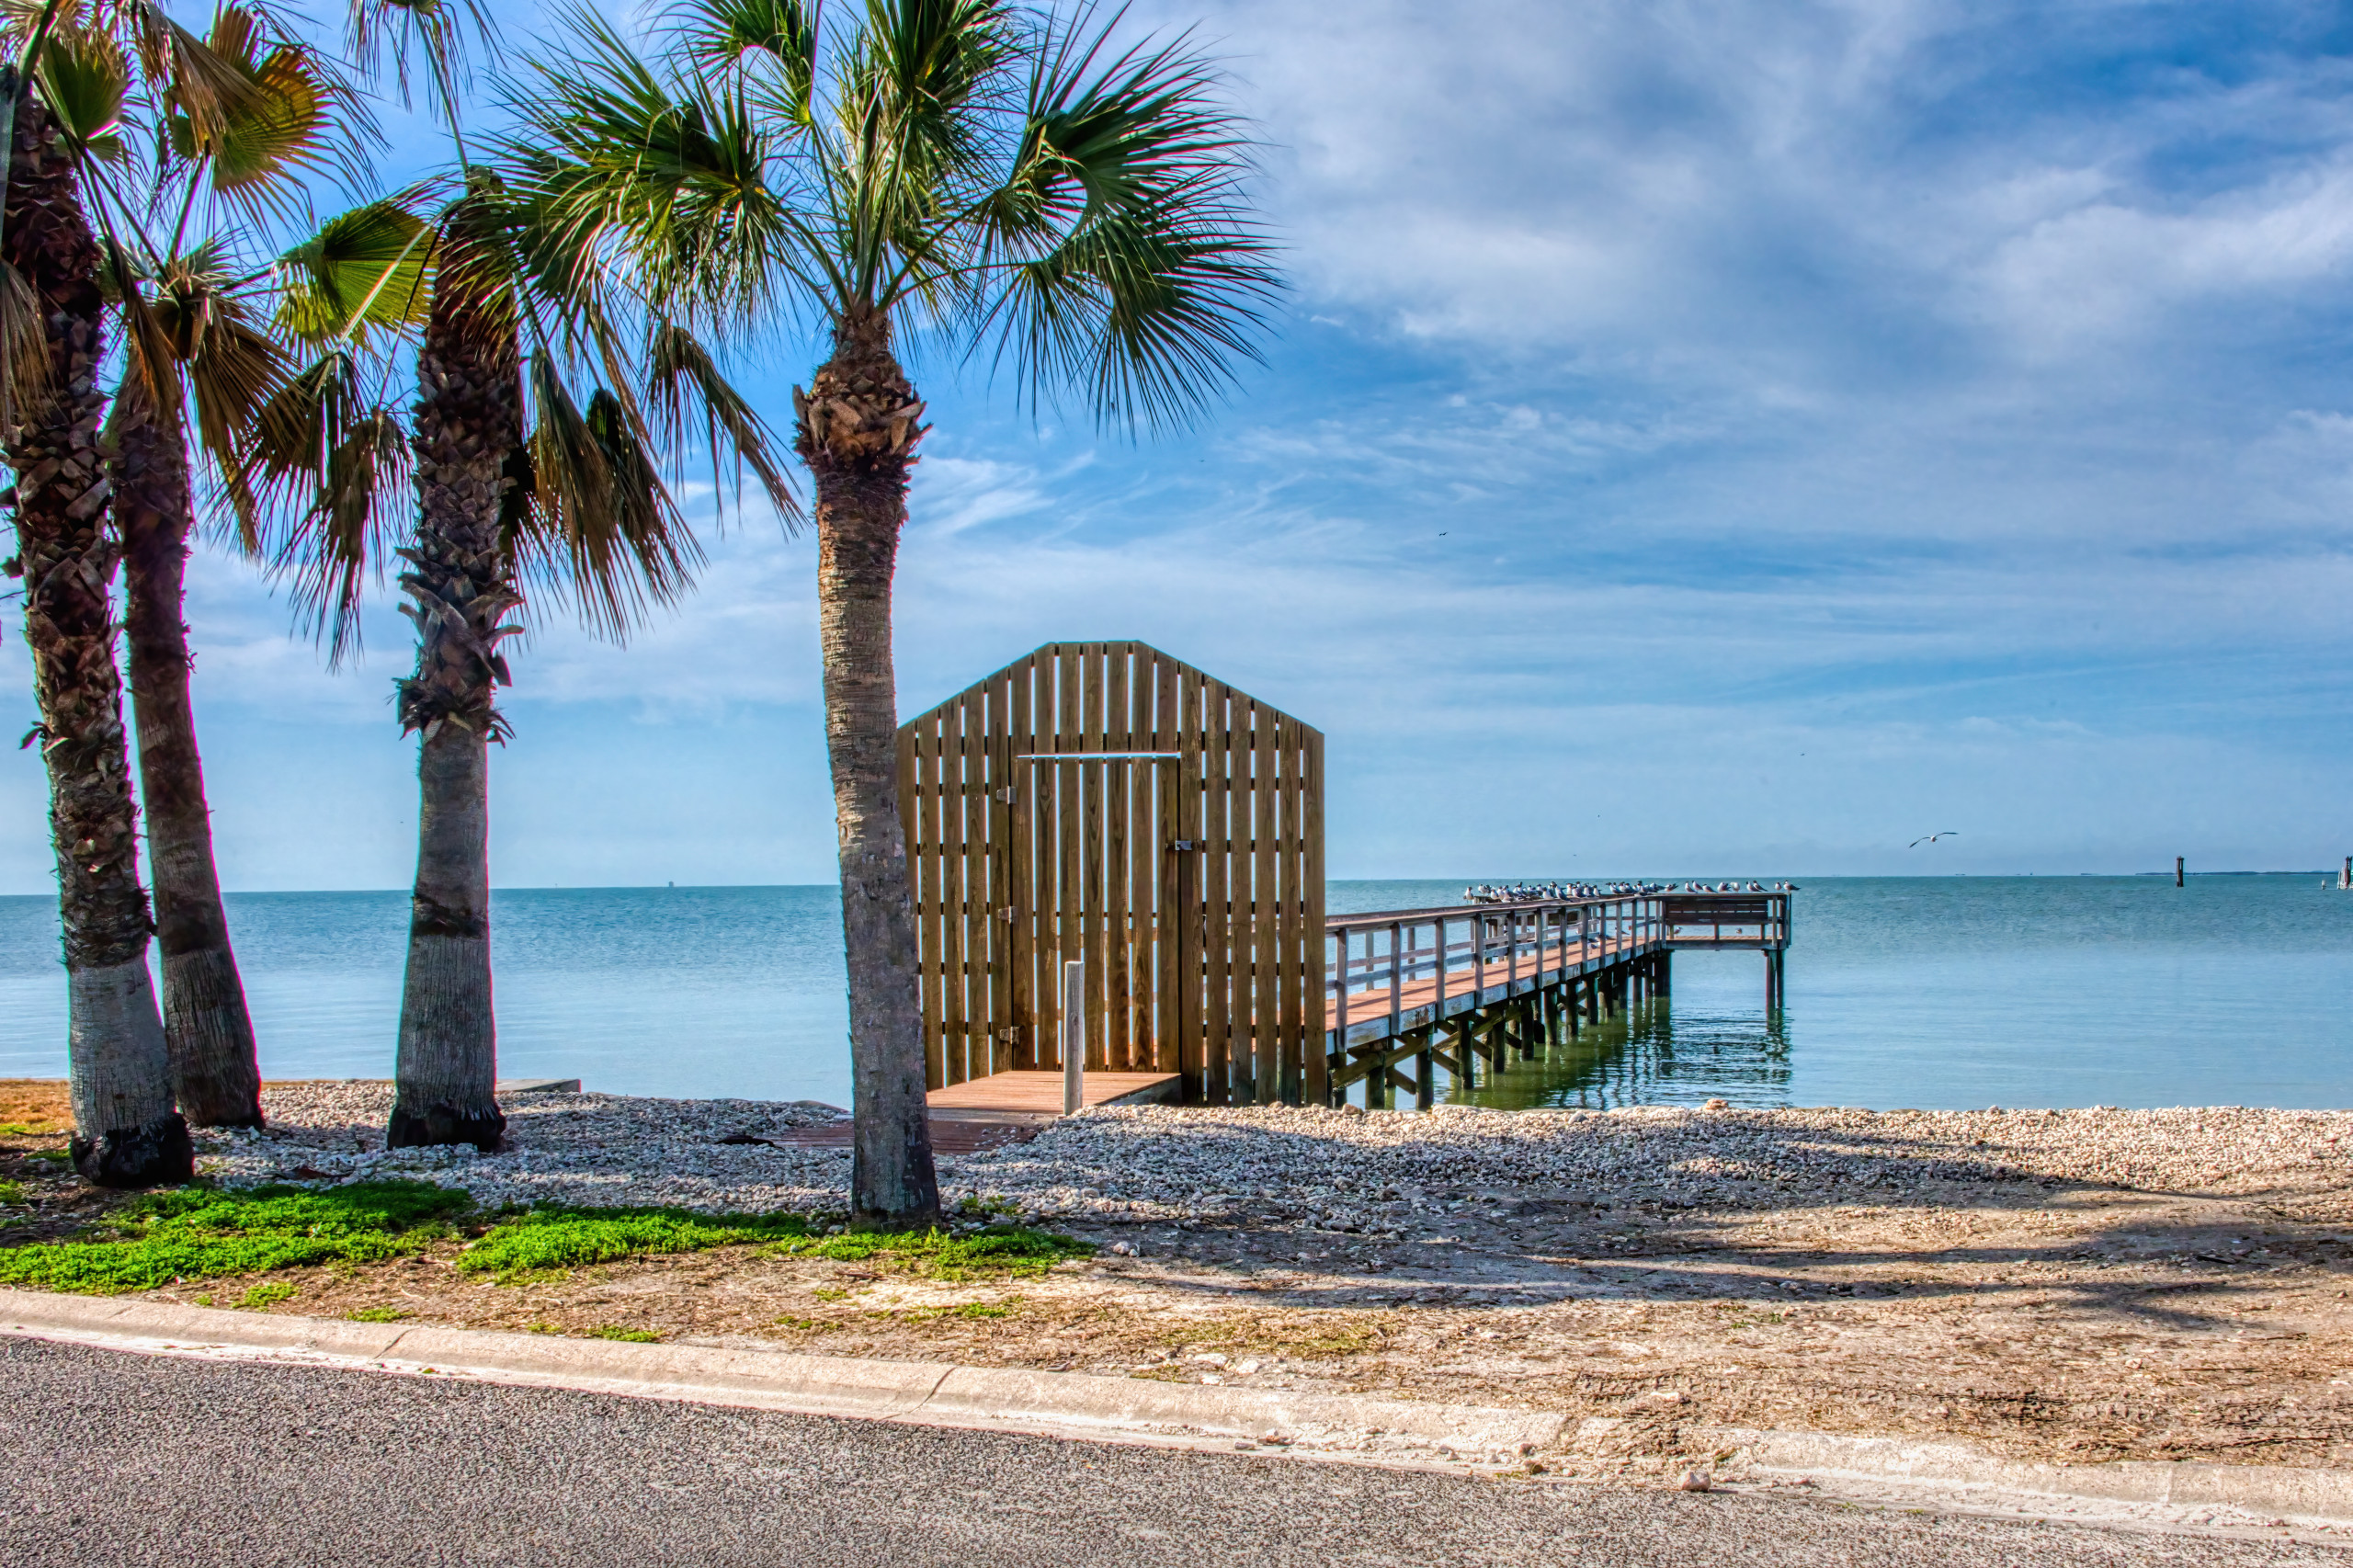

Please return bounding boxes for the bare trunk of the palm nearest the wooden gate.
[793,313,938,1229]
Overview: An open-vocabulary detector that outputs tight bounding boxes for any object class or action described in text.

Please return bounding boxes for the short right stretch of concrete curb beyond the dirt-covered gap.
[1706,1426,2353,1526]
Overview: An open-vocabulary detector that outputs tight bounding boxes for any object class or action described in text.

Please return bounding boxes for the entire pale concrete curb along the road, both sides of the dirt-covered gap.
[18,1290,2353,1526]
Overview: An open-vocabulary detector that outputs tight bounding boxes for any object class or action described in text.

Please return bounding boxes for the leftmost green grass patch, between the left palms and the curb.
[0,1182,473,1295]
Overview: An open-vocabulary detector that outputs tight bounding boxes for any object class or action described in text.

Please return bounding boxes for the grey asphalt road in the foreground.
[0,1340,2353,1568]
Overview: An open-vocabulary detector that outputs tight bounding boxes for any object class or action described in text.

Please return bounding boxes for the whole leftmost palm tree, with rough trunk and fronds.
[0,0,303,1187]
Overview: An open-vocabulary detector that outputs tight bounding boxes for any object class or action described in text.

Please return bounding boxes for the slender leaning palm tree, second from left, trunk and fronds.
[93,5,369,1125]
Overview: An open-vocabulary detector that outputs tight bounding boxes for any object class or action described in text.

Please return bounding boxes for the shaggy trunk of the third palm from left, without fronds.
[386,281,522,1152]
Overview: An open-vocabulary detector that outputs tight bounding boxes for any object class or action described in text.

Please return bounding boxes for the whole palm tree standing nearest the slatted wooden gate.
[516,0,1276,1227]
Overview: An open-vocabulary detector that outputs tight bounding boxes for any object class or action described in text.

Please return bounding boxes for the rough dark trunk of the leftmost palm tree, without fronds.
[0,97,195,1187]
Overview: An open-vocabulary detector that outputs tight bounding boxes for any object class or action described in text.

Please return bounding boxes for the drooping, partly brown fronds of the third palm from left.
[252,174,793,654]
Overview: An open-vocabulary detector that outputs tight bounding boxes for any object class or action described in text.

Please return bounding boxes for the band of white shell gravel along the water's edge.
[198,1083,2353,1236]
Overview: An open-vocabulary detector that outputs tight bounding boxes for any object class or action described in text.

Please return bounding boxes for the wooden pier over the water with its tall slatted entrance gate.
[899,642,1789,1116]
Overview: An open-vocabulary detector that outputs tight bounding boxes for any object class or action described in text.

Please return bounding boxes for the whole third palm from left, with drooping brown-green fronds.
[256,179,790,1149]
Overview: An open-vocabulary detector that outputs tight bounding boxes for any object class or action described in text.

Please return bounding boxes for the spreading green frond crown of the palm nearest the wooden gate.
[511,0,1278,426]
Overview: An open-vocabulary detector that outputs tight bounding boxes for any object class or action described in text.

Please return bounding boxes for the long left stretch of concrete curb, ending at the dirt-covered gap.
[0,1290,1564,1464]
